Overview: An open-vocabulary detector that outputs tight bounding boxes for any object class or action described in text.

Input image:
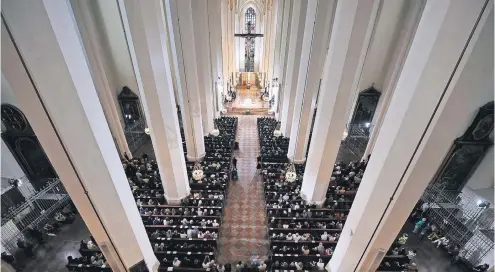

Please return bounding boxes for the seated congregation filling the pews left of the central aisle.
[68,117,237,271]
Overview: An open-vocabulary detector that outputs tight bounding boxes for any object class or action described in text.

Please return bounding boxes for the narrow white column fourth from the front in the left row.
[191,1,216,135]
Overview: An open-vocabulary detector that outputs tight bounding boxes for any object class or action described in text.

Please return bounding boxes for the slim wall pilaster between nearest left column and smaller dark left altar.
[73,1,132,158]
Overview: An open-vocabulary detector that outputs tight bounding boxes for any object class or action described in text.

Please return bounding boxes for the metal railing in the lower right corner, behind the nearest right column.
[421,182,494,265]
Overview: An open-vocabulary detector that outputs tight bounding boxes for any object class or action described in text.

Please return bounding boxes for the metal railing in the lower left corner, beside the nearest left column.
[1,179,71,254]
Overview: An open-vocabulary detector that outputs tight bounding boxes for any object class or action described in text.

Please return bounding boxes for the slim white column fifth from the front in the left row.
[207,0,224,117]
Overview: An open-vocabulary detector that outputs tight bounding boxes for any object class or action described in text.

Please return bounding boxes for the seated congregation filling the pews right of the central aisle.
[258,118,366,271]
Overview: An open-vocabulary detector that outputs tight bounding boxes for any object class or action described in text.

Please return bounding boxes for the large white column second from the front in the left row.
[119,0,190,203]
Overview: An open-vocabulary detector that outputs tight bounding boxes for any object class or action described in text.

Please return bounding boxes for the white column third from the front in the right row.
[287,0,334,163]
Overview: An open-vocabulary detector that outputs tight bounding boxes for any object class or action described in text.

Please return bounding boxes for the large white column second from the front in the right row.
[301,0,380,204]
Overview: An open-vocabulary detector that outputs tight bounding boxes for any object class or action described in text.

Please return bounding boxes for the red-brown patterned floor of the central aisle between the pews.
[217,115,269,265]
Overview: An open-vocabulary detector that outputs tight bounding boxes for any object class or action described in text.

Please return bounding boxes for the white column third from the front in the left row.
[165,0,205,161]
